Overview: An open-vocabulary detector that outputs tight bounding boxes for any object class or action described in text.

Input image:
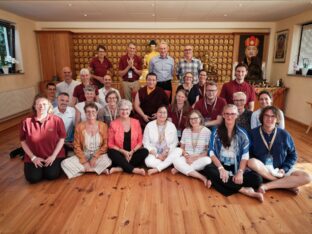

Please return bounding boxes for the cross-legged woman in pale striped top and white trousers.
[171,110,211,187]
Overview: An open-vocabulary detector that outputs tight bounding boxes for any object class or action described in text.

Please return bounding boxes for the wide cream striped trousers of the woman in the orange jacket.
[61,154,112,179]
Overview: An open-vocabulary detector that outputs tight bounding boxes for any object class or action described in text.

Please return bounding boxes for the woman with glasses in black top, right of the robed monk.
[177,72,199,107]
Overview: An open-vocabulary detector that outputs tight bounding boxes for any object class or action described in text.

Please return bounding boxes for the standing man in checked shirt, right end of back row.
[177,45,203,84]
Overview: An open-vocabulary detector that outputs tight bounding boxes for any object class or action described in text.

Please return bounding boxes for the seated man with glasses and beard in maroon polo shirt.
[194,81,226,127]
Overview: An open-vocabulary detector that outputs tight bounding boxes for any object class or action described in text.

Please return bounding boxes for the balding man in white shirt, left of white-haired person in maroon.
[56,67,80,103]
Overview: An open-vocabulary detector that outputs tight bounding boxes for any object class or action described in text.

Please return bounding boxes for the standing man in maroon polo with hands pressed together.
[119,42,143,101]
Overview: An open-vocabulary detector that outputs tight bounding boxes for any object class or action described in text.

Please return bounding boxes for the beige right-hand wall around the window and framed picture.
[271,10,312,124]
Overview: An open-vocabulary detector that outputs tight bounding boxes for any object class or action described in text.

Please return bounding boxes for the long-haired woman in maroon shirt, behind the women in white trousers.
[168,89,192,139]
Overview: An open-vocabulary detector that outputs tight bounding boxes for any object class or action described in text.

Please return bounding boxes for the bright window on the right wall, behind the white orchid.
[297,22,312,69]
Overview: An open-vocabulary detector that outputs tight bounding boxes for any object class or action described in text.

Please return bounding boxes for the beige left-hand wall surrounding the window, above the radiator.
[0,10,41,92]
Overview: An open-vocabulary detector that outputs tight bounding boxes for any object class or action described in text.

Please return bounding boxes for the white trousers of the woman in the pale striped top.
[173,156,211,175]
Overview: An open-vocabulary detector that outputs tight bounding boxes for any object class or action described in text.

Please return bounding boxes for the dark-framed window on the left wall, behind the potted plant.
[0,20,15,71]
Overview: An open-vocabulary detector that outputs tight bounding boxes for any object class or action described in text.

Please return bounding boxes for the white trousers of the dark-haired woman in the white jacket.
[145,148,182,172]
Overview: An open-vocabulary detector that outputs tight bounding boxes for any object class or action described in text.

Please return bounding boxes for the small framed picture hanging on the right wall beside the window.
[273,29,288,63]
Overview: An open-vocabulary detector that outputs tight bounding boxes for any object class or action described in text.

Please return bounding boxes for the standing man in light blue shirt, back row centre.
[149,41,174,102]
